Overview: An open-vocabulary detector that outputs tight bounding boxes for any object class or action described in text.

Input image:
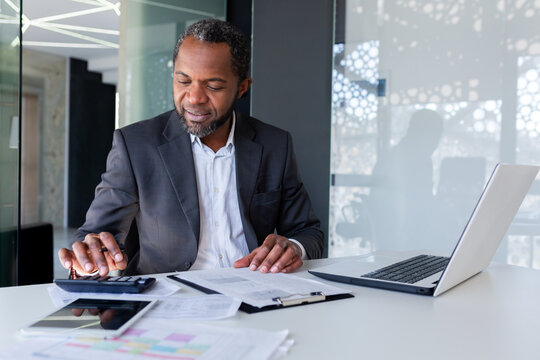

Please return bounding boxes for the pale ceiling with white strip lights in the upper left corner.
[0,0,120,83]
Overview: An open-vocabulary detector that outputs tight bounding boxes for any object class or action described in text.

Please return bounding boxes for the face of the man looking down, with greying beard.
[173,36,251,137]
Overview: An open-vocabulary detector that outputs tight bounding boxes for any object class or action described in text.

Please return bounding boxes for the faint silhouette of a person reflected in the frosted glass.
[369,109,442,250]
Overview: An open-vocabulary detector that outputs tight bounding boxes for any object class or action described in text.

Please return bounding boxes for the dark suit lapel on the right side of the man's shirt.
[234,112,262,251]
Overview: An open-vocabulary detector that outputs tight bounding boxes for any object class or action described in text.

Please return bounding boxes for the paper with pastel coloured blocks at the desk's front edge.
[0,318,291,360]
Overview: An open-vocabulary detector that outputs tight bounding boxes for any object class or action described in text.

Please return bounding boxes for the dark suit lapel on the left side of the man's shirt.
[158,111,200,242]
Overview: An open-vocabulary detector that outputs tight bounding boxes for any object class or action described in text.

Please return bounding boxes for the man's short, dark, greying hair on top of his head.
[173,19,251,81]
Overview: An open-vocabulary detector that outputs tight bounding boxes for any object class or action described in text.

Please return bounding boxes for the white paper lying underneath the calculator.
[47,279,181,307]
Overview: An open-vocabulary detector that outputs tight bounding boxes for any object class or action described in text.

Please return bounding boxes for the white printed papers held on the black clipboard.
[174,268,350,308]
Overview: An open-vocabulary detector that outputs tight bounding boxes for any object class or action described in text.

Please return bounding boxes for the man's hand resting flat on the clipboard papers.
[234,234,303,273]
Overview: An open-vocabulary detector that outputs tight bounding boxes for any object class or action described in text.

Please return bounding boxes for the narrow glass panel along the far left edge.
[0,1,20,286]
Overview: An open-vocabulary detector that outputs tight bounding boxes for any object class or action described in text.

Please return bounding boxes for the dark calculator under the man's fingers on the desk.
[54,275,156,294]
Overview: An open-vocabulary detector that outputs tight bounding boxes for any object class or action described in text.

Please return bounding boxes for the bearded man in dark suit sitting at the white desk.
[59,20,324,276]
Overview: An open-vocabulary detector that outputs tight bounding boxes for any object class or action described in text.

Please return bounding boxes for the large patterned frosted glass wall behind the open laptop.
[329,0,540,268]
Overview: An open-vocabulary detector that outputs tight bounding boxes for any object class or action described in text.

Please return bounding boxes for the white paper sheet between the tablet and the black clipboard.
[145,294,242,320]
